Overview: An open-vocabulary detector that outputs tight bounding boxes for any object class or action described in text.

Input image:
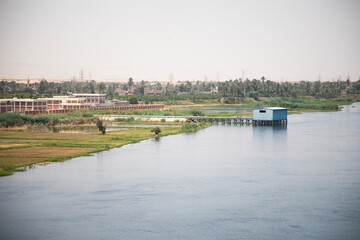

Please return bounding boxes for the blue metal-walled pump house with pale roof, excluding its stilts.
[253,107,287,121]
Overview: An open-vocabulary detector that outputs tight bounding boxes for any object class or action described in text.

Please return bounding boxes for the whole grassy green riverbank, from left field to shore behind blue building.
[0,95,356,176]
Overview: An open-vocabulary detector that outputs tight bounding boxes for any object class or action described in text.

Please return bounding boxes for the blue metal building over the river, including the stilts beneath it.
[253,107,287,125]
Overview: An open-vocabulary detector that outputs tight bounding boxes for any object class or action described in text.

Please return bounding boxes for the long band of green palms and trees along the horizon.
[0,77,360,103]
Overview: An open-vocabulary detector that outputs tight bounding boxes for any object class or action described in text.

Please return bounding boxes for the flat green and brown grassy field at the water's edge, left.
[0,122,210,176]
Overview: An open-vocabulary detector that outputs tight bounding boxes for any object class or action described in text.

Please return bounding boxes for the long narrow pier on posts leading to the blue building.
[94,115,287,126]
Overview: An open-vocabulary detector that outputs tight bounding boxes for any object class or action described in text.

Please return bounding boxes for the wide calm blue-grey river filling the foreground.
[0,103,360,240]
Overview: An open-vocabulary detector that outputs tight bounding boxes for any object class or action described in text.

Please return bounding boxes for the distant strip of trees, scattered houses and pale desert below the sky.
[0,76,360,99]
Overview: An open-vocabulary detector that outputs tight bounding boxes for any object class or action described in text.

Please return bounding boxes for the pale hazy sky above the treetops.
[0,0,360,81]
